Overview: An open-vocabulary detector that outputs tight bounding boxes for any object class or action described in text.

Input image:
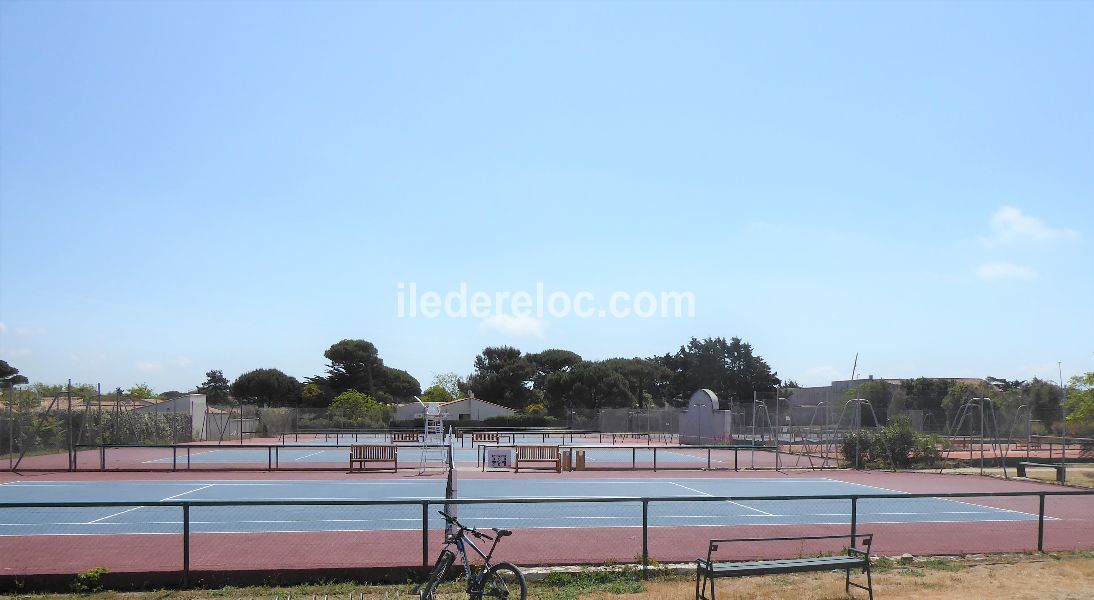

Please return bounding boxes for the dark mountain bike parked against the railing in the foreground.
[415,510,528,600]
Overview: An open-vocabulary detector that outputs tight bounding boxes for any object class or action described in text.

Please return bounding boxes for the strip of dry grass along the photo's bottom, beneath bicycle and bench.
[0,552,1094,600]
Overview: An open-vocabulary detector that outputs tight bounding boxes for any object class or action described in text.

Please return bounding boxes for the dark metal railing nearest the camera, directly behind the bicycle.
[0,491,1094,586]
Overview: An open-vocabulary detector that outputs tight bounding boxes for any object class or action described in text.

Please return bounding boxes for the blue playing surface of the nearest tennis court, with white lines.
[0,477,1037,535]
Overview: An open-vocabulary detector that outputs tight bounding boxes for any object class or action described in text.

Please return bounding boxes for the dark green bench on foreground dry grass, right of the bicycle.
[695,533,874,600]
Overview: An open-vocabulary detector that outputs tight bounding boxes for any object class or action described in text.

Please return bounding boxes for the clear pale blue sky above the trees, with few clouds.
[0,1,1094,390]
